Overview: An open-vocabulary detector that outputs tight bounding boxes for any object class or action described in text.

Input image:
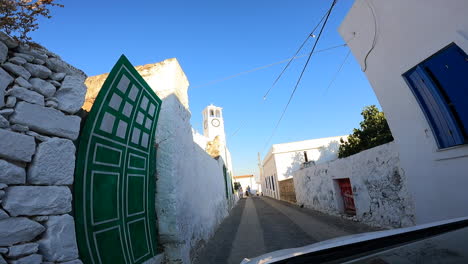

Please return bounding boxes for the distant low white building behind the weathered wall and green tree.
[260,136,348,199]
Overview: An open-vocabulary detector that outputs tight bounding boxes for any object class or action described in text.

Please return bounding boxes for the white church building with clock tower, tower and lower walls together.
[192,104,233,175]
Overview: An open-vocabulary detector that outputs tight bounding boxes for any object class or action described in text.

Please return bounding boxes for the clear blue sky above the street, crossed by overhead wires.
[31,0,378,177]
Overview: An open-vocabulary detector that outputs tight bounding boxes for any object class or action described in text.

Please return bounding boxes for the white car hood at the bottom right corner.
[241,217,468,264]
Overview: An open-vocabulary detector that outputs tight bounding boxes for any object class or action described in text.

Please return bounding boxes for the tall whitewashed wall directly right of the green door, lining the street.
[144,59,235,263]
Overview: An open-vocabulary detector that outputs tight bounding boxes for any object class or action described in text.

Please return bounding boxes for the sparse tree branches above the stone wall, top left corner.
[0,0,63,42]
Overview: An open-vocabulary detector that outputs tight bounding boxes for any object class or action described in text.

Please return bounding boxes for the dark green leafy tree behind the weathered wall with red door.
[338,105,393,158]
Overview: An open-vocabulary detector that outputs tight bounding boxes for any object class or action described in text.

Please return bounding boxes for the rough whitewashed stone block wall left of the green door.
[0,32,86,264]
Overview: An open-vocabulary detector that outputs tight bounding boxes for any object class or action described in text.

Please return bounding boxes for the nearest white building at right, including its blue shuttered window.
[339,0,468,224]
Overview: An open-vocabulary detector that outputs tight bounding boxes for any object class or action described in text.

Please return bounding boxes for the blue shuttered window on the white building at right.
[403,44,468,148]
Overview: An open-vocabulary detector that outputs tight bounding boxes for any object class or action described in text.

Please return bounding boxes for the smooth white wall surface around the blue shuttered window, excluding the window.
[339,0,468,224]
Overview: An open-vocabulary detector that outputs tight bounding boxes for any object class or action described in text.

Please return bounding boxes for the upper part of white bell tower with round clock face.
[202,104,226,144]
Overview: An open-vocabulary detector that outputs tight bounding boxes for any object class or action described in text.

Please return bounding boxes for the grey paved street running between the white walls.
[195,197,375,264]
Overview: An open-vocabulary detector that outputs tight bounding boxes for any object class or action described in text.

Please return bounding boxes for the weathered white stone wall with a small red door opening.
[294,142,415,227]
